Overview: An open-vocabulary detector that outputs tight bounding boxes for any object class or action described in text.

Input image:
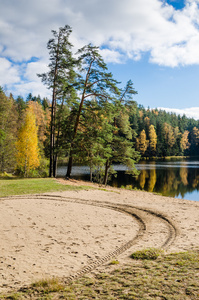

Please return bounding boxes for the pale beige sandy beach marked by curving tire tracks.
[0,180,199,293]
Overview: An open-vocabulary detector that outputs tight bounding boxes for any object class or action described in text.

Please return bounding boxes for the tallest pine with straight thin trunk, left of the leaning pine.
[38,25,75,177]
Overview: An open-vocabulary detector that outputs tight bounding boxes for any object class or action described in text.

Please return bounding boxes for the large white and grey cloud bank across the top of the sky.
[0,0,199,96]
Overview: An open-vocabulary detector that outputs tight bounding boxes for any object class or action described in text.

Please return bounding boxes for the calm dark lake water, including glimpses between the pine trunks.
[58,159,199,201]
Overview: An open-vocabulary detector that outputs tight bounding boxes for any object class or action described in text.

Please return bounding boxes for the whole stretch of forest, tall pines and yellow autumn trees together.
[0,25,199,184]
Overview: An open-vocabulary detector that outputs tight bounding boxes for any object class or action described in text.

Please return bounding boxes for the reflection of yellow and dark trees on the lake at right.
[110,161,199,200]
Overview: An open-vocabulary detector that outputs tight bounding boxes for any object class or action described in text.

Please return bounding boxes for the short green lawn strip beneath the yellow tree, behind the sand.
[0,178,89,197]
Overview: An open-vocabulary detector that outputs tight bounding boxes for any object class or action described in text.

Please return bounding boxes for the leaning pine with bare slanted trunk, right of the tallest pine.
[66,44,119,178]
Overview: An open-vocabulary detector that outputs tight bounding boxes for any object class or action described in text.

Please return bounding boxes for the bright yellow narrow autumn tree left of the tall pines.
[16,109,40,176]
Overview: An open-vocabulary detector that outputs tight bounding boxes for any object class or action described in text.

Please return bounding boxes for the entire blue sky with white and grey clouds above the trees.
[0,0,199,119]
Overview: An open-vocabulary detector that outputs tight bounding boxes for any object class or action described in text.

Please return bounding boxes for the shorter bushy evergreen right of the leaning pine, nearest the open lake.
[104,80,140,185]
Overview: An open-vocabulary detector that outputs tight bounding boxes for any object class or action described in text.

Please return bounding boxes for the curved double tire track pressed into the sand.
[1,194,178,283]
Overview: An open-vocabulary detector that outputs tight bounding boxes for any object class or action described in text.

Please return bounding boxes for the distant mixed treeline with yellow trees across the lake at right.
[130,105,199,157]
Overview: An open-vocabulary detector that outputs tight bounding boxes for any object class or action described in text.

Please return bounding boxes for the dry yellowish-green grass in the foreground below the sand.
[0,251,199,300]
